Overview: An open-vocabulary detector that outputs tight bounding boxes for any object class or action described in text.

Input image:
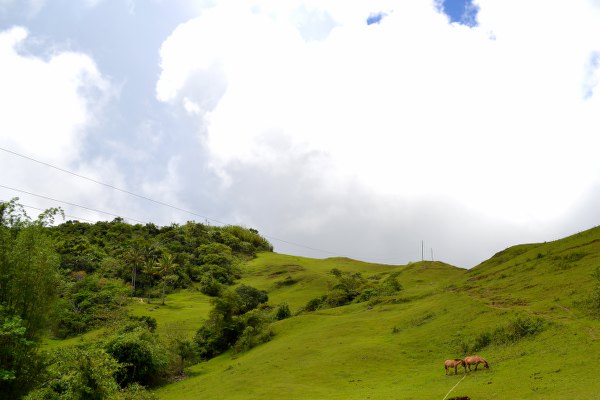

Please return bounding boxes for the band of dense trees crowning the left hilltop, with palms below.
[48,217,272,295]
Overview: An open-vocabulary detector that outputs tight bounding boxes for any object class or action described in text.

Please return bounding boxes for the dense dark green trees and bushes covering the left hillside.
[0,199,274,399]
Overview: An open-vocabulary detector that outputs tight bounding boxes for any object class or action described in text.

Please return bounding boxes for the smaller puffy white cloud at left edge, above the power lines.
[0,27,109,165]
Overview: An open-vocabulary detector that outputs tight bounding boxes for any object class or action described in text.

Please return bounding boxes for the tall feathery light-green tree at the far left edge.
[0,199,61,398]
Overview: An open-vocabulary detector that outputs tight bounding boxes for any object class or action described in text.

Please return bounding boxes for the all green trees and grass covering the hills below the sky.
[0,201,600,400]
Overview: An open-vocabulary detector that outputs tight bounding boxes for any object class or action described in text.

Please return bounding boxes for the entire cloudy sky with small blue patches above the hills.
[0,0,600,268]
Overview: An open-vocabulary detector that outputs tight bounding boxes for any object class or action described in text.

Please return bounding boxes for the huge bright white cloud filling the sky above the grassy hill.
[157,0,600,228]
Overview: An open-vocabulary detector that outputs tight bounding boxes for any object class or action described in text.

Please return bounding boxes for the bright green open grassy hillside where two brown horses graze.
[113,228,600,399]
